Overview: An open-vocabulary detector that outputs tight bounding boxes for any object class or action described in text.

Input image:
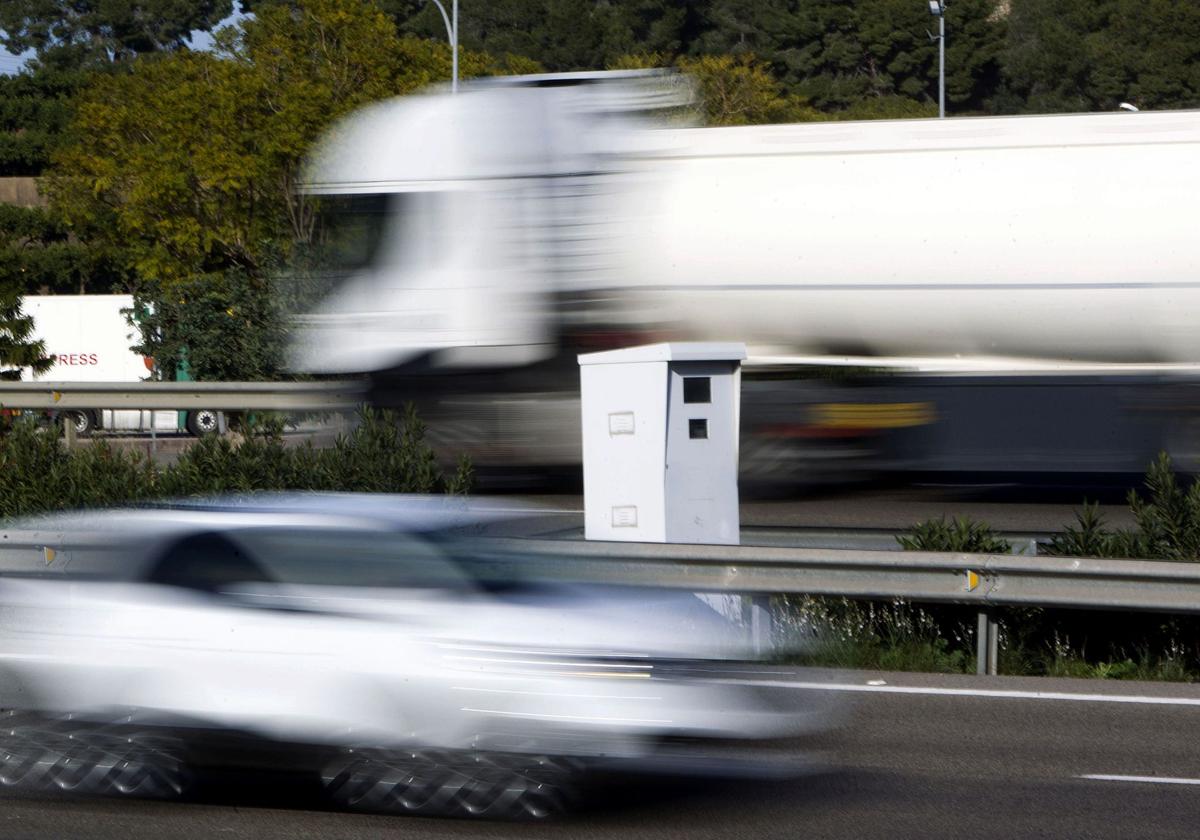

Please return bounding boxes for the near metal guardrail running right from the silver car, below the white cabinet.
[477,539,1200,674]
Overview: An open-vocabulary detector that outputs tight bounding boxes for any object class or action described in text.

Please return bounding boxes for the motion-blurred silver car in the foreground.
[0,496,827,817]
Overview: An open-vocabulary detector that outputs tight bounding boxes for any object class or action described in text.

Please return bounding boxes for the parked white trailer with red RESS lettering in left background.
[22,294,221,434]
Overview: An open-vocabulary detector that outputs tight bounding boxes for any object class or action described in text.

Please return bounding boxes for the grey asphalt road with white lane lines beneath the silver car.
[0,670,1200,840]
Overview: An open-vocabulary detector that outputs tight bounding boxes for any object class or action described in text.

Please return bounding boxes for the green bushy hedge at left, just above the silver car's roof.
[0,409,470,520]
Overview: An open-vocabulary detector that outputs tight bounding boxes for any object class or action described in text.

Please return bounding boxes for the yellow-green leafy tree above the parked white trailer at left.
[46,53,276,283]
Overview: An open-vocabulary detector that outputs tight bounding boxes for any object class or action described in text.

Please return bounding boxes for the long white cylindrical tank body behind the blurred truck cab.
[604,112,1200,362]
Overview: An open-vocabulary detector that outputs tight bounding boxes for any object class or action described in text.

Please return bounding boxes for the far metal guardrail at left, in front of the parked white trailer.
[0,382,366,412]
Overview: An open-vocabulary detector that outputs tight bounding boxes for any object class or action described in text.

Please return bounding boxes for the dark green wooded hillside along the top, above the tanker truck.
[244,0,1200,118]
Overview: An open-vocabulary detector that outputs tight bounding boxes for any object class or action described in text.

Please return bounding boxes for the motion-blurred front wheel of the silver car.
[322,750,577,820]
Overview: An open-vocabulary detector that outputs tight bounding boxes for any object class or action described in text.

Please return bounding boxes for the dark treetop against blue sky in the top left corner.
[0,0,233,66]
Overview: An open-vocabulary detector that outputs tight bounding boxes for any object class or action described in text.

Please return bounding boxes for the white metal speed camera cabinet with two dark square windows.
[578,342,746,545]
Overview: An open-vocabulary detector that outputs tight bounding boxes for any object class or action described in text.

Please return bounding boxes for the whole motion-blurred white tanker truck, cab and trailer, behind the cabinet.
[288,73,1200,484]
